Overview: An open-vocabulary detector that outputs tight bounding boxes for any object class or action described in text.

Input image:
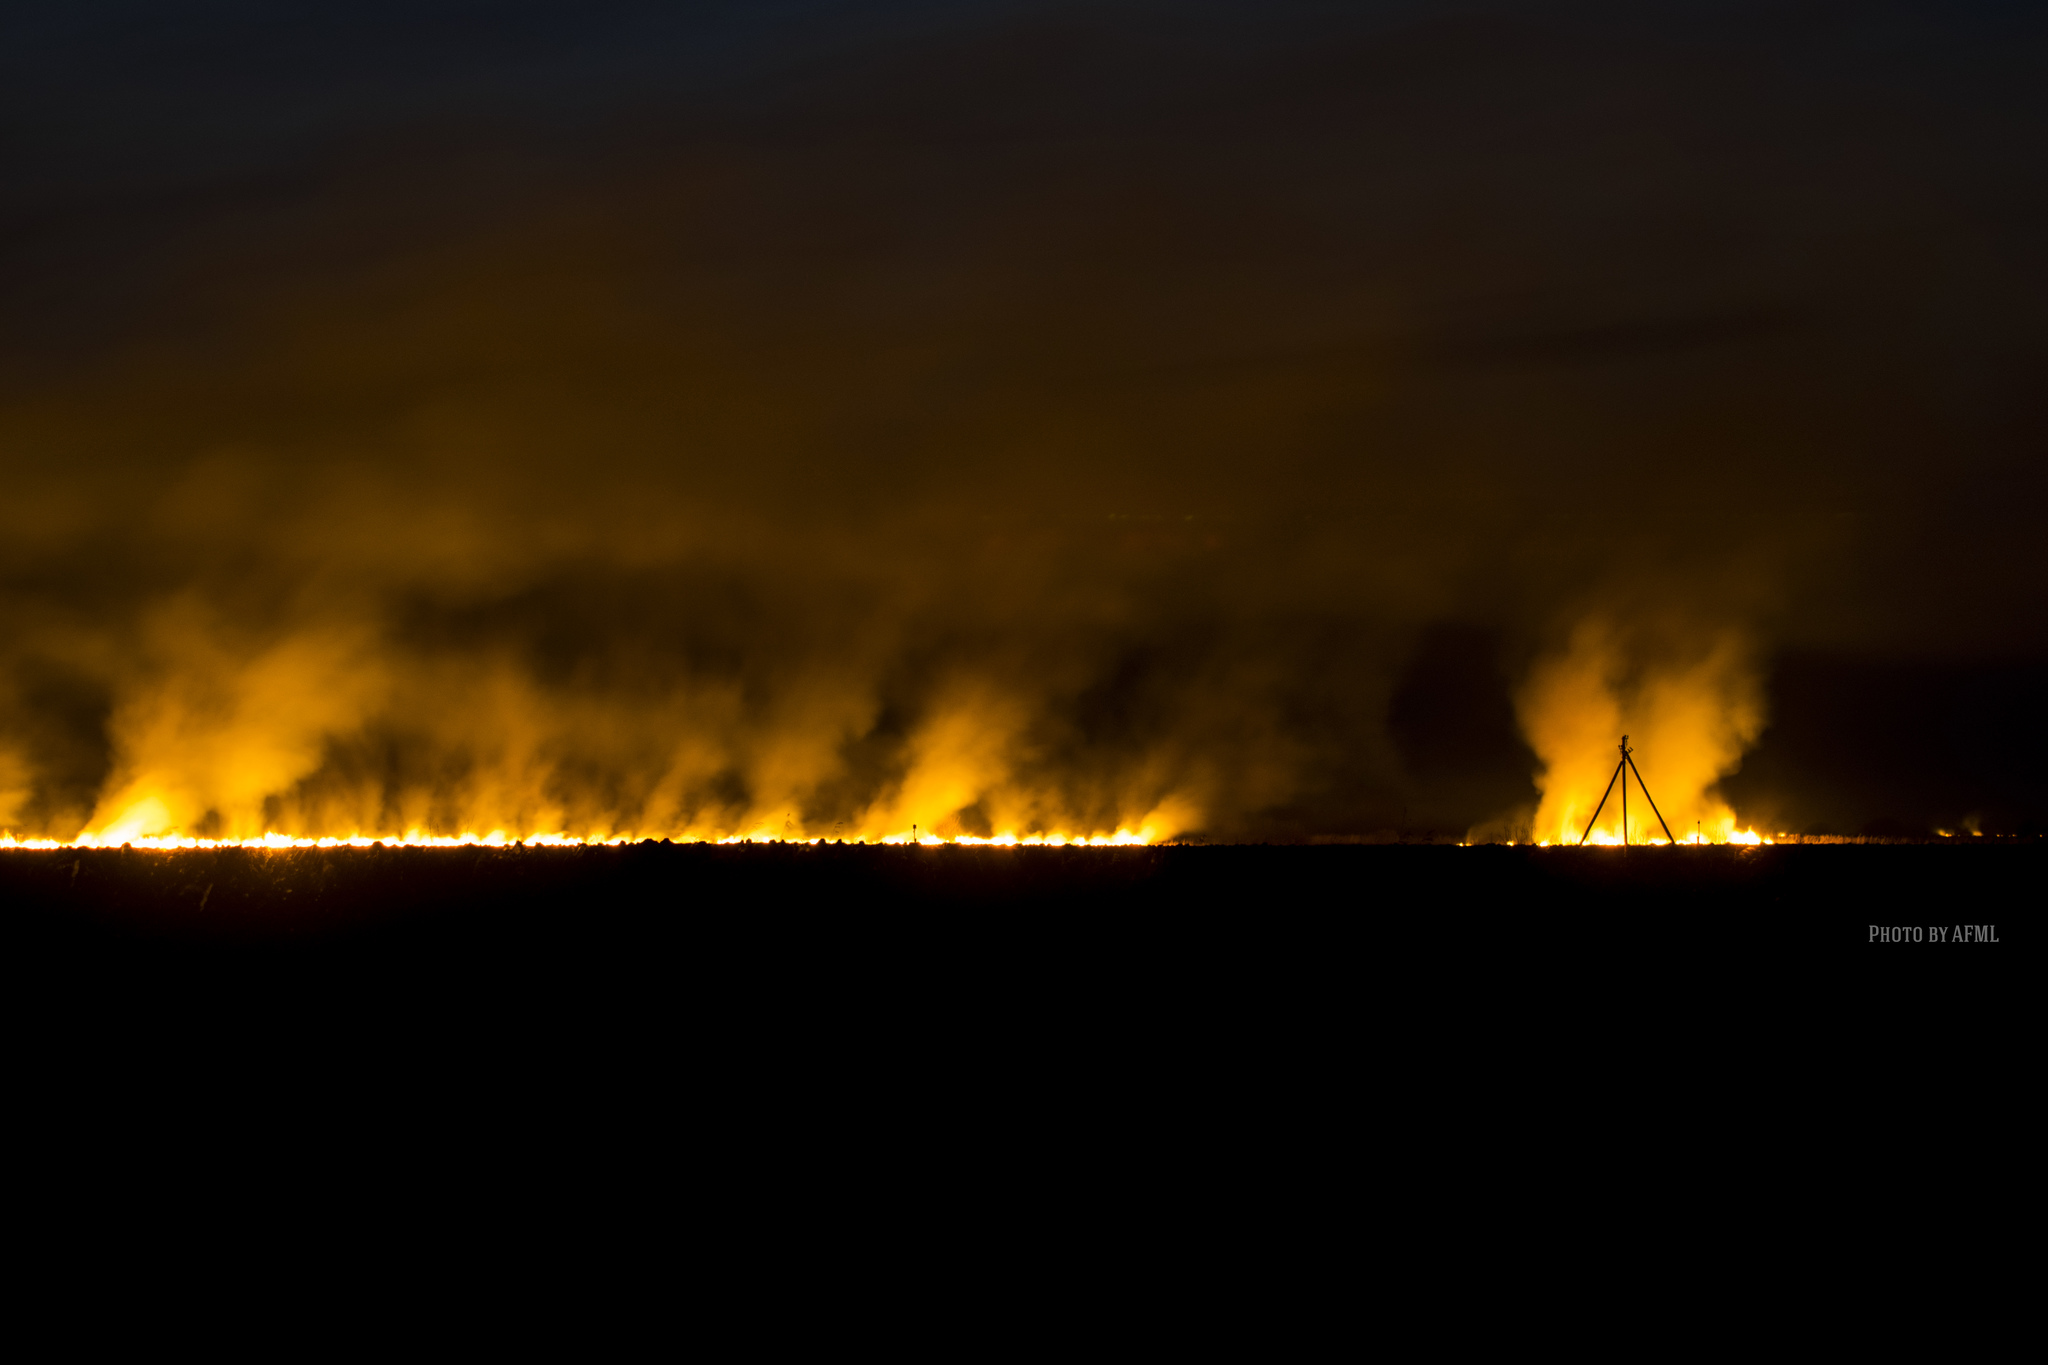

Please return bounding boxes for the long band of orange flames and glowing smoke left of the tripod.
[19,634,1202,849]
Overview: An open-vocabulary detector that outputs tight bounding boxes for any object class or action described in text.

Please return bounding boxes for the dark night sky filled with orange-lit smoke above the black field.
[0,0,2048,837]
